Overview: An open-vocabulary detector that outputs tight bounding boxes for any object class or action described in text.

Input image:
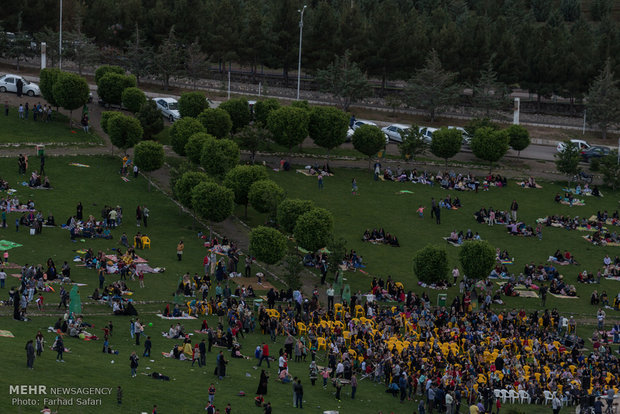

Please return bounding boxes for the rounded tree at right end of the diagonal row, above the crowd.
[293,207,334,252]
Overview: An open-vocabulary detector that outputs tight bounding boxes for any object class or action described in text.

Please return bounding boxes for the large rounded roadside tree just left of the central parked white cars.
[308,106,349,156]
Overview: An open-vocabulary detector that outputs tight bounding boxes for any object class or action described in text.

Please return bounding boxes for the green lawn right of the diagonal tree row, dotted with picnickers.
[268,169,620,316]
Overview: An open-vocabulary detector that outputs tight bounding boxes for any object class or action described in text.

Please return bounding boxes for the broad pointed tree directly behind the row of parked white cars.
[405,49,460,122]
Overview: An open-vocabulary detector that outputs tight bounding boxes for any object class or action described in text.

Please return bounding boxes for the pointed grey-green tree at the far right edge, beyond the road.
[586,59,620,139]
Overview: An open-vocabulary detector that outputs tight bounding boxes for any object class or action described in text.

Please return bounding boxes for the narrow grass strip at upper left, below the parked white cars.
[0,107,102,146]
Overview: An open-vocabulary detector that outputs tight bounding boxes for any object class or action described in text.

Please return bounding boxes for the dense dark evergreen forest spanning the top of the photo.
[0,0,620,97]
